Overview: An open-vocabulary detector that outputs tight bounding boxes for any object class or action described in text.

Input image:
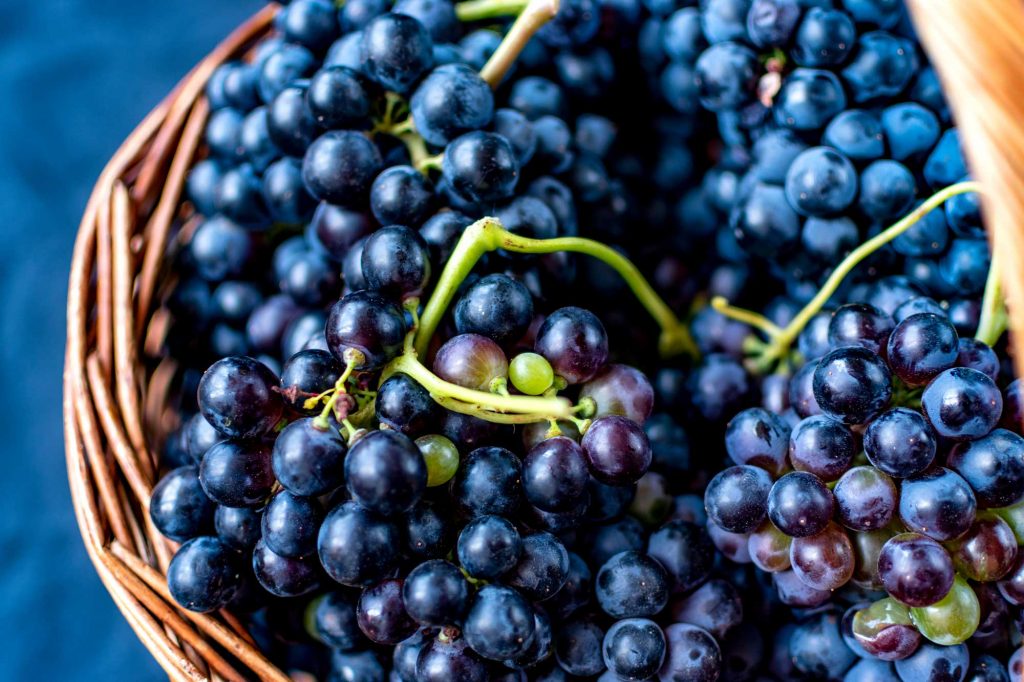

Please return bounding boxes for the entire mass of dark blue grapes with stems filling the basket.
[150,0,1024,682]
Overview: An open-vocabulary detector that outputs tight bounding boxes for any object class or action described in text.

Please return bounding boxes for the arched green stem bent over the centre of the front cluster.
[416,217,698,357]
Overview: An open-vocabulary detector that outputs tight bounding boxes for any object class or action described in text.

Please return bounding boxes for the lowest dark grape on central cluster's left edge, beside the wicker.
[167,537,241,613]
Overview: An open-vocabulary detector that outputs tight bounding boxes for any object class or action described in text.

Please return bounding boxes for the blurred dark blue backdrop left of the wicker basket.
[0,0,261,682]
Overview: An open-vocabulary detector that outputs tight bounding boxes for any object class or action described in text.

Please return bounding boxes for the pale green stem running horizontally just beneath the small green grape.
[381,353,572,422]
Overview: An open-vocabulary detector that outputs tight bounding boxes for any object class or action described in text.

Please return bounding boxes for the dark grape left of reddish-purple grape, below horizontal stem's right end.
[522,436,590,512]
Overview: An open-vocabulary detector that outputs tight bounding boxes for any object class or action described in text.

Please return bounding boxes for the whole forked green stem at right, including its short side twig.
[712,181,983,374]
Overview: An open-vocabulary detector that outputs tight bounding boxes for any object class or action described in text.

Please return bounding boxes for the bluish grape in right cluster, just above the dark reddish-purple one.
[899,467,977,542]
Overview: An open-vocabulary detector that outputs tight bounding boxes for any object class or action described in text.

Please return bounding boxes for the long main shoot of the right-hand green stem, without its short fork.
[754,181,981,372]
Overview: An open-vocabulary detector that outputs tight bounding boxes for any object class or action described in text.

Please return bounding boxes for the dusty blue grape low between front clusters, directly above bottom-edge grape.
[594,551,669,619]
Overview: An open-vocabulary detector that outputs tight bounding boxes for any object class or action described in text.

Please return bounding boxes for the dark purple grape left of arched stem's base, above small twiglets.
[326,291,406,370]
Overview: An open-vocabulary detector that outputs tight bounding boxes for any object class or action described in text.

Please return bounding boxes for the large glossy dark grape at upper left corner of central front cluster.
[199,356,284,438]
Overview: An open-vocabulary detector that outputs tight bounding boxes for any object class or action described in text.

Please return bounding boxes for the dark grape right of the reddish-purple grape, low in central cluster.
[401,559,469,626]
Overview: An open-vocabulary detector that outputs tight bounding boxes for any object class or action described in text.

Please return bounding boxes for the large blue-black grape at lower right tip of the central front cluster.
[463,585,537,660]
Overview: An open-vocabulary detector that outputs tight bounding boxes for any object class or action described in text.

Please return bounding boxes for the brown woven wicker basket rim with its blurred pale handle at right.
[63,0,1024,680]
